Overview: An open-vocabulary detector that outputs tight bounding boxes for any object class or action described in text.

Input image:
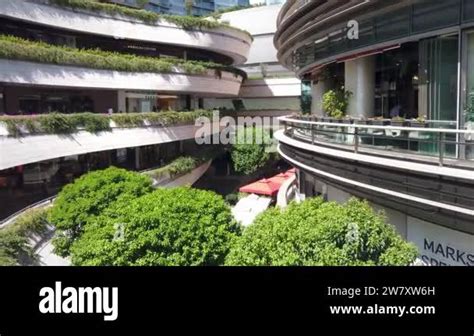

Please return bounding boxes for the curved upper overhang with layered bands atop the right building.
[274,0,474,75]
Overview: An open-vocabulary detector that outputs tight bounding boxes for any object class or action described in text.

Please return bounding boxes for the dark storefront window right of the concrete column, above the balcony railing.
[375,35,460,123]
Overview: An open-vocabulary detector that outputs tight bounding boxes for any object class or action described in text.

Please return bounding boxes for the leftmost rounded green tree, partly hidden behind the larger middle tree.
[49,167,152,256]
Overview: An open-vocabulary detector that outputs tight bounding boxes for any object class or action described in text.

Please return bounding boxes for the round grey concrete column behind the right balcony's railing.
[344,56,375,118]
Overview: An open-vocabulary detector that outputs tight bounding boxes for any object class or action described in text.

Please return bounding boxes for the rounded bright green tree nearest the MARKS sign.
[226,198,417,266]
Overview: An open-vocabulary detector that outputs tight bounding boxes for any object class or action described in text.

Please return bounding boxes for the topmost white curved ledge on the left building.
[0,0,252,64]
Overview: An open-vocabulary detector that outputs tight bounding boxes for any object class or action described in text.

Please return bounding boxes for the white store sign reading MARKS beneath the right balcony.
[407,218,474,266]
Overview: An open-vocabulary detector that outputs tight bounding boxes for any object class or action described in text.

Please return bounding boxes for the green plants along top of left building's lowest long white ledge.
[0,110,212,137]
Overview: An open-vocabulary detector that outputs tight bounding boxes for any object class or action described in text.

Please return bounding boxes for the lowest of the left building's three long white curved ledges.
[0,125,219,170]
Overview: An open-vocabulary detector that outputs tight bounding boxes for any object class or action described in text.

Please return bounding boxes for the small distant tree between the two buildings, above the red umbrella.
[231,127,270,174]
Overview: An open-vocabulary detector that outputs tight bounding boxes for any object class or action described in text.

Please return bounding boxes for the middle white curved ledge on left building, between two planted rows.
[0,59,242,96]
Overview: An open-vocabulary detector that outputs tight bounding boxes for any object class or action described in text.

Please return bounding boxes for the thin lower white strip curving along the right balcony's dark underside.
[278,145,474,217]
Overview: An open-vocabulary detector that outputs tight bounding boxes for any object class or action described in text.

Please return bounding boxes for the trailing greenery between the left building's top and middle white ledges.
[0,35,246,78]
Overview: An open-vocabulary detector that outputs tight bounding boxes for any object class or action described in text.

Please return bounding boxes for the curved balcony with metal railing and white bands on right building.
[275,117,474,234]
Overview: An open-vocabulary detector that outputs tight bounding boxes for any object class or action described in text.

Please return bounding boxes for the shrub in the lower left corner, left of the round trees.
[0,209,48,266]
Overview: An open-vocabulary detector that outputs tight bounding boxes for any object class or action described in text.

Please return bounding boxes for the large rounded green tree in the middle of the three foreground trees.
[71,187,239,266]
